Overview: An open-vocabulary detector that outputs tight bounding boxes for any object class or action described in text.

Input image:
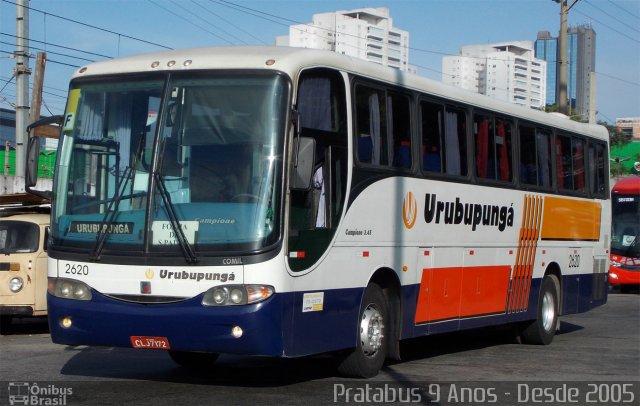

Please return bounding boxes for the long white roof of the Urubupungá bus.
[72,46,609,141]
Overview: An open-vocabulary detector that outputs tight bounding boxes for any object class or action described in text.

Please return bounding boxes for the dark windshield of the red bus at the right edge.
[611,194,640,258]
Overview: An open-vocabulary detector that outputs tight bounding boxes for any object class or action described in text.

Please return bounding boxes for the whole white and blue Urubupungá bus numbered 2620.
[28,47,611,377]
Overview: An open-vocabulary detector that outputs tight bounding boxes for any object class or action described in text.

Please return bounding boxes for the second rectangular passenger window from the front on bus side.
[420,101,467,176]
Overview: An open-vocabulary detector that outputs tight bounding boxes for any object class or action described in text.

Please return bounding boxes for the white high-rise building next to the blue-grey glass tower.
[442,41,546,108]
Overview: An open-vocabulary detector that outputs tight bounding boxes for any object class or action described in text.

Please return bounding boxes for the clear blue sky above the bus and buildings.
[0,0,640,123]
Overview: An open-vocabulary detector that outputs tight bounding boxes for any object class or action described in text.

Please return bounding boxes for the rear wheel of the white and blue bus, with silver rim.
[520,275,560,345]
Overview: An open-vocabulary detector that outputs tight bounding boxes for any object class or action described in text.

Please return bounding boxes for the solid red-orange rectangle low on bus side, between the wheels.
[415,265,511,324]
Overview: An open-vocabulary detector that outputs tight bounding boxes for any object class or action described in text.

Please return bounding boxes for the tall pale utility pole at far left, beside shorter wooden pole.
[14,0,31,184]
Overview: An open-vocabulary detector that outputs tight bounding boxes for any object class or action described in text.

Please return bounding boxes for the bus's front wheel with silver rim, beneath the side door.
[338,283,389,378]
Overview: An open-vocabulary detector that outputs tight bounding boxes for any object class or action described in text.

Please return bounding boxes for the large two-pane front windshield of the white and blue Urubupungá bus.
[52,74,288,259]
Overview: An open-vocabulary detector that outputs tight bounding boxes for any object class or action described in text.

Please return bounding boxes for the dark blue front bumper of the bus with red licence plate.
[47,292,287,356]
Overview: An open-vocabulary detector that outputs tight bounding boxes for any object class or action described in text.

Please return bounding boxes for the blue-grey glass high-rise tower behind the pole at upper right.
[535,24,596,118]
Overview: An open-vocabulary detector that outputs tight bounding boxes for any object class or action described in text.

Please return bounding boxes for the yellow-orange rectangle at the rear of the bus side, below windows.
[542,196,602,241]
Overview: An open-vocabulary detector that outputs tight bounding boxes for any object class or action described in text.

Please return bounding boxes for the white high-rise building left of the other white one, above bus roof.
[276,7,411,71]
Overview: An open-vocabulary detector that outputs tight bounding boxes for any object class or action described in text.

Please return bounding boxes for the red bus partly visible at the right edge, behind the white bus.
[609,175,640,291]
